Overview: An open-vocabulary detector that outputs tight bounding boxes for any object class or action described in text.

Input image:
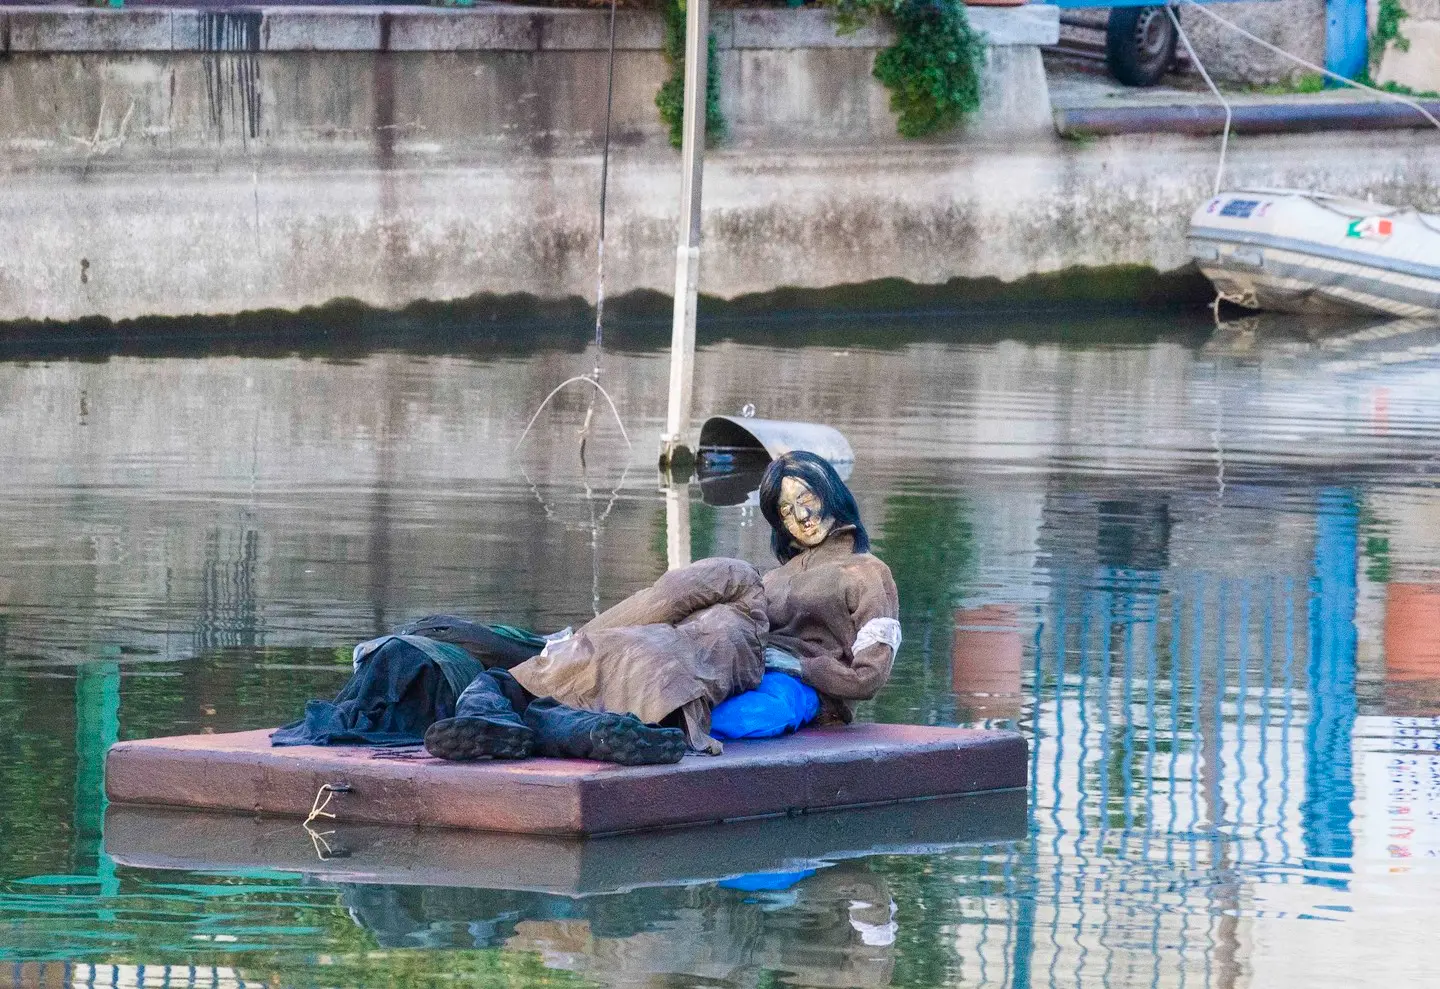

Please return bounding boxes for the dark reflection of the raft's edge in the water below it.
[105,790,1027,897]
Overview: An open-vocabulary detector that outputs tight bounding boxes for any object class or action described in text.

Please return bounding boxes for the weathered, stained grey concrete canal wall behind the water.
[0,6,1440,320]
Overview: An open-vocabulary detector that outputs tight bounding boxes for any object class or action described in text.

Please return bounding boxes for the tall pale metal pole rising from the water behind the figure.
[660,0,710,466]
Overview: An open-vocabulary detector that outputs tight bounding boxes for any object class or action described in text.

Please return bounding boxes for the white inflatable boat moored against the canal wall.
[1188,189,1440,317]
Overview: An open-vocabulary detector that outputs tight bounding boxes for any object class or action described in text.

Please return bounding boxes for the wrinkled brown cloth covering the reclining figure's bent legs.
[510,559,768,751]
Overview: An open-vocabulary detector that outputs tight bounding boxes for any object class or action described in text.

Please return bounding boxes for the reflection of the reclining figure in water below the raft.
[505,862,899,989]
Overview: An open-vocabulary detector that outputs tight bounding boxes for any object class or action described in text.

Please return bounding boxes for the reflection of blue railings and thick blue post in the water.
[1015,489,1376,986]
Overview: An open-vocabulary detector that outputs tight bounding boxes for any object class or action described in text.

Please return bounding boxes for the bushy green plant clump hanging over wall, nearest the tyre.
[824,0,985,137]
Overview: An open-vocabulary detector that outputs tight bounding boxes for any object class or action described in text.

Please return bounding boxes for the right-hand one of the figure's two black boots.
[526,697,685,766]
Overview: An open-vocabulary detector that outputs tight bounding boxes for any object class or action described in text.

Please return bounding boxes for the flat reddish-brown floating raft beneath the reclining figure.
[105,724,1027,835]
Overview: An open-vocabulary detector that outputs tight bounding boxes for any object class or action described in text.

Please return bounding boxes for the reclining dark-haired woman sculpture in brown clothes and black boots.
[425,451,900,764]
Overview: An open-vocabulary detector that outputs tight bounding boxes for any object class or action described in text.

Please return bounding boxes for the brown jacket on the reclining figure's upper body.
[765,530,900,724]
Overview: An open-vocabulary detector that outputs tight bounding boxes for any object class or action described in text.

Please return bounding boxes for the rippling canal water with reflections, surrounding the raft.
[0,314,1440,989]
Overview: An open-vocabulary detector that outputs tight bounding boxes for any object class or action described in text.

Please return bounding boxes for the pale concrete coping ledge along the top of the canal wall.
[0,4,1060,53]
